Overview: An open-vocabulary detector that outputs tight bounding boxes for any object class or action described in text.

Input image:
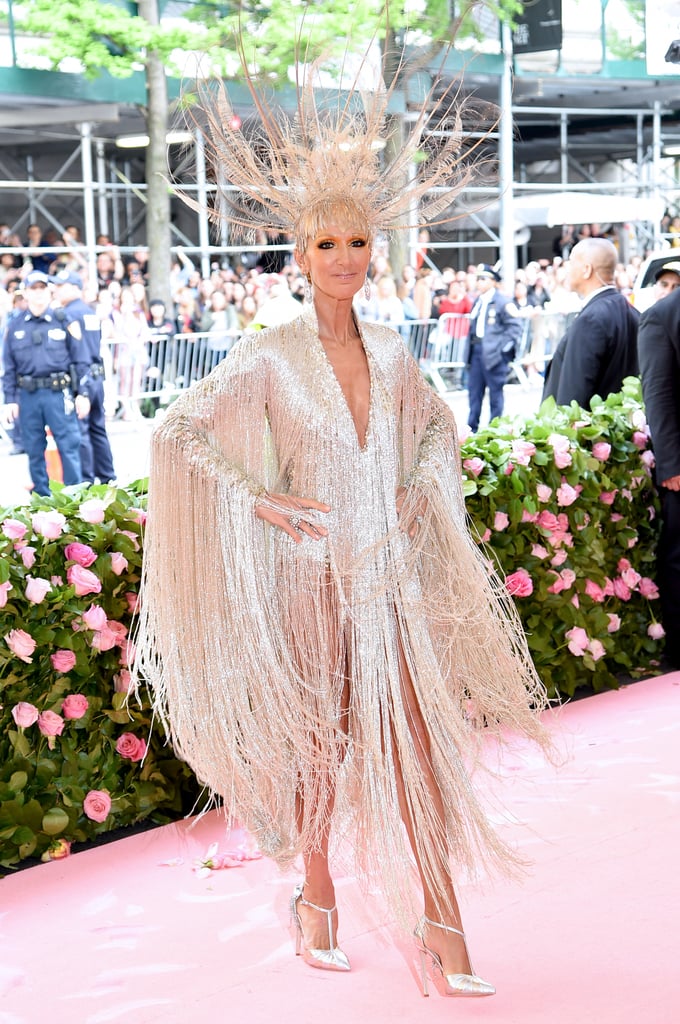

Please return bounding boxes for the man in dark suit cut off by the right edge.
[638,288,680,669]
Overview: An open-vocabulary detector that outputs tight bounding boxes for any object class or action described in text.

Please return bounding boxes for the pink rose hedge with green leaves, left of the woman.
[0,485,198,868]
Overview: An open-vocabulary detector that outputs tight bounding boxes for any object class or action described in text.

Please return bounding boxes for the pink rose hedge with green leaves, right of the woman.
[462,378,664,696]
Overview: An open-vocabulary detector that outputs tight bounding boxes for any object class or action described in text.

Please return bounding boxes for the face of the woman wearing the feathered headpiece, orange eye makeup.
[295,222,371,300]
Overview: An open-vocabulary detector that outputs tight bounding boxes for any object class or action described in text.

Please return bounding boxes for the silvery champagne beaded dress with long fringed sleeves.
[137,309,545,921]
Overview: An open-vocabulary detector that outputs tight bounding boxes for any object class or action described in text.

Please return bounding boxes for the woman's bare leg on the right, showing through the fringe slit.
[392,642,472,974]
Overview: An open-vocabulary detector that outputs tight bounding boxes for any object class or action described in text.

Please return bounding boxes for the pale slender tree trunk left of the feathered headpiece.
[138,0,172,310]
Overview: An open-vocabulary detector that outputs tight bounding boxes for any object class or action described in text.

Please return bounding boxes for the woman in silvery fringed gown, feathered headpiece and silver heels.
[137,41,547,995]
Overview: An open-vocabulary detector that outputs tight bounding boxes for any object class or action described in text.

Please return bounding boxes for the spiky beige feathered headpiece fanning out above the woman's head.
[180,21,498,245]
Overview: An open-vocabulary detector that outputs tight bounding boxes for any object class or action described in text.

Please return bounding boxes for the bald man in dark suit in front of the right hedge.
[543,239,639,409]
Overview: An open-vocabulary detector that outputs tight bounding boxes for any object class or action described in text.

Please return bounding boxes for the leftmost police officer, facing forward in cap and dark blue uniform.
[3,270,89,495]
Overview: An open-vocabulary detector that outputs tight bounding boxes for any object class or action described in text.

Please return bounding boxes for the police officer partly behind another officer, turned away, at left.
[52,270,116,483]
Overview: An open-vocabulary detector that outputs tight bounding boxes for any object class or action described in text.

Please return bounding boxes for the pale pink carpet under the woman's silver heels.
[0,673,680,1024]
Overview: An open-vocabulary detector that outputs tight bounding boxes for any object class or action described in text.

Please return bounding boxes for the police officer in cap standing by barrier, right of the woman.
[467,263,523,430]
